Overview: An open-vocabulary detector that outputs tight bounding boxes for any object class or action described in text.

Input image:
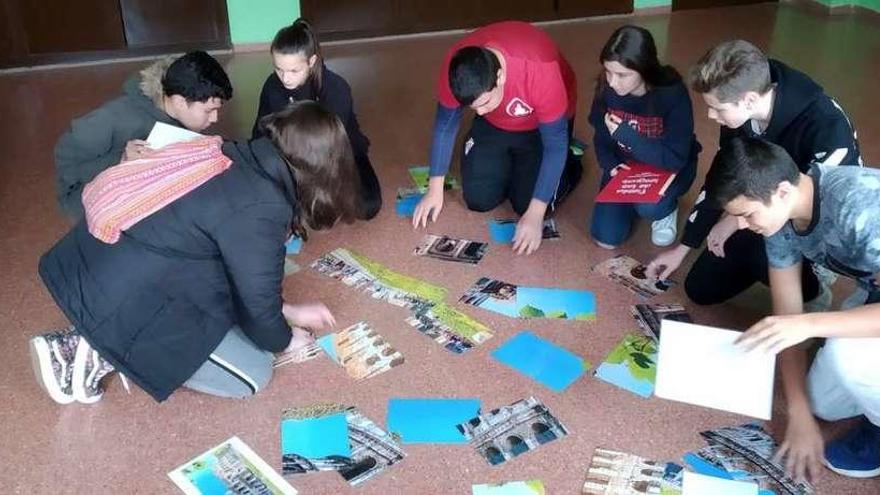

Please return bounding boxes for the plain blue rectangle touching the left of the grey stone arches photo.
[385,399,480,444]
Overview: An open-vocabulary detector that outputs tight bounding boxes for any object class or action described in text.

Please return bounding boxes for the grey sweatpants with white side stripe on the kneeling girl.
[183,326,274,399]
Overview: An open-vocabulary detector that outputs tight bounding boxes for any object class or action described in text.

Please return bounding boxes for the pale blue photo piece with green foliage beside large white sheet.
[594,333,657,398]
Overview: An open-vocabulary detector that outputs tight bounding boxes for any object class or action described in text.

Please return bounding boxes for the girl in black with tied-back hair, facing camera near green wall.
[253,19,382,220]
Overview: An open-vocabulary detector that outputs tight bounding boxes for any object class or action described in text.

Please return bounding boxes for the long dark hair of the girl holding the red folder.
[599,25,681,87]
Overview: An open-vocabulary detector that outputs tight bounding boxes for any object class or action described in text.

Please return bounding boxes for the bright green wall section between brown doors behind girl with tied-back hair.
[226,0,299,45]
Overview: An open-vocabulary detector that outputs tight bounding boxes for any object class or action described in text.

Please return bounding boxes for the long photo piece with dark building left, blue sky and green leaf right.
[459,277,596,321]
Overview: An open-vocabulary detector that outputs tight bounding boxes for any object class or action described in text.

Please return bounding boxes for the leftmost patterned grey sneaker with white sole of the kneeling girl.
[29,326,82,404]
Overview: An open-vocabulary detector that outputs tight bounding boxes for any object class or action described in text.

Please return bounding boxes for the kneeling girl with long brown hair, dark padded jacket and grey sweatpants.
[31,102,358,403]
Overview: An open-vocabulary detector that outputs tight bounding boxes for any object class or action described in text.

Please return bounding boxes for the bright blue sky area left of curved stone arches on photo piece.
[281,412,351,459]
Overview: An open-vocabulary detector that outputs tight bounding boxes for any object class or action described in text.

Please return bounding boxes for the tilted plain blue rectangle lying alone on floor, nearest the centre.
[492,331,586,392]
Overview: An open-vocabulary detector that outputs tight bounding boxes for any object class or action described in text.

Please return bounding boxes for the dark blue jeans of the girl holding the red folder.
[590,164,696,246]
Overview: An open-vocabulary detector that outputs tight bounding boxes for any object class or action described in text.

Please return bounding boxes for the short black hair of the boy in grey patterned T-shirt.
[706,137,800,208]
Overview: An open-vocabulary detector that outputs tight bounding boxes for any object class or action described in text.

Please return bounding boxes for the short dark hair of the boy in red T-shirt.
[449,46,501,106]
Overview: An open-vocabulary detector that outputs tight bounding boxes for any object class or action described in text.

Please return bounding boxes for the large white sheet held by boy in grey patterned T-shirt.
[654,320,776,420]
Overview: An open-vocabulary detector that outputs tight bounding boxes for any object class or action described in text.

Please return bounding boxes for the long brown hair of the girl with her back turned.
[261,100,360,239]
